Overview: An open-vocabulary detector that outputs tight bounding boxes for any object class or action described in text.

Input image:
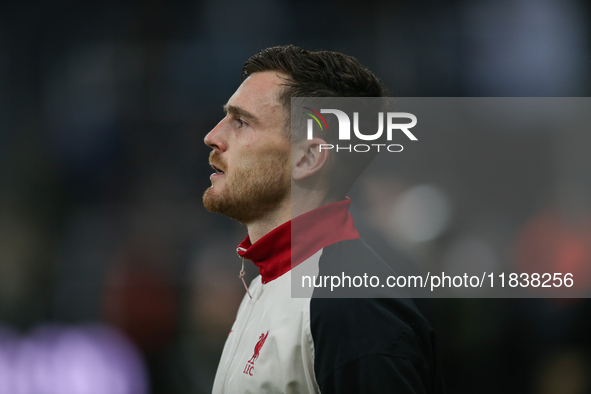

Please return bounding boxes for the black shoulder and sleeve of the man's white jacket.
[310,240,444,394]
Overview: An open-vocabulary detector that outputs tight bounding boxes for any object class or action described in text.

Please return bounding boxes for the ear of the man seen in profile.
[292,138,329,181]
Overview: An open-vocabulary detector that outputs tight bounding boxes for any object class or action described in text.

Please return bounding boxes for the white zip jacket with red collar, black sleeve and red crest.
[213,198,443,394]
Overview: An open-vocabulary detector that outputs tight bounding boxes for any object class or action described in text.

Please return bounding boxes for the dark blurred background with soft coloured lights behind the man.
[0,0,591,394]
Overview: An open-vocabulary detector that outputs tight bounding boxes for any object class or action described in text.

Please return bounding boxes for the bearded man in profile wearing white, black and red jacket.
[203,46,442,393]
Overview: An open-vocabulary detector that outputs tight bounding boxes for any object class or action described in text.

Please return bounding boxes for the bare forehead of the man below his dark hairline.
[228,71,284,123]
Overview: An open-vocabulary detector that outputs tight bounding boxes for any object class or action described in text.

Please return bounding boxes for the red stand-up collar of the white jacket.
[237,197,359,283]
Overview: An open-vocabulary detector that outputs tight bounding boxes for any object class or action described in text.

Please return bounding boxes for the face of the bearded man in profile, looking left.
[203,71,291,224]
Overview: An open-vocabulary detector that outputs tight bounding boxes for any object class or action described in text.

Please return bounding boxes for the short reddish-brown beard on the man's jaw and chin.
[203,152,290,224]
